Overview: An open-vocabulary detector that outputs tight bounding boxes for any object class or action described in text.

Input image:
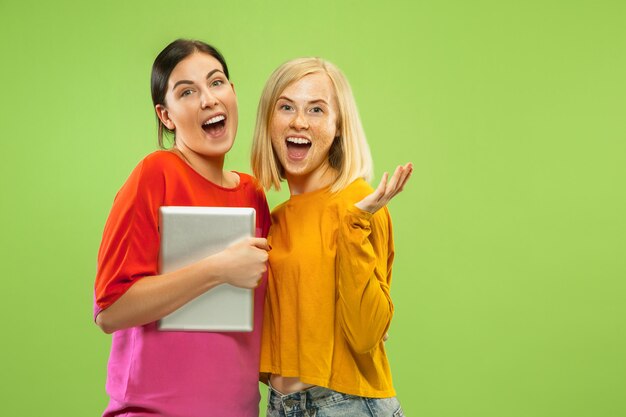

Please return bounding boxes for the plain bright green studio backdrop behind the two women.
[0,0,626,417]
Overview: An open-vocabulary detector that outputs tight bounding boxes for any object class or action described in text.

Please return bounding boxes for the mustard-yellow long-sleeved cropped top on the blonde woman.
[261,179,395,398]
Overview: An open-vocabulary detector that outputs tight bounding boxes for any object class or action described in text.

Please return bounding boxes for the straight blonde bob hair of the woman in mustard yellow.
[252,58,372,192]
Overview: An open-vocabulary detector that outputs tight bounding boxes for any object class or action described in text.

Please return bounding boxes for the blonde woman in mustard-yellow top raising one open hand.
[252,58,413,417]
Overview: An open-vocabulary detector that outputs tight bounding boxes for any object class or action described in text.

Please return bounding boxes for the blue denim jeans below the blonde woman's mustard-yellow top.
[267,386,404,417]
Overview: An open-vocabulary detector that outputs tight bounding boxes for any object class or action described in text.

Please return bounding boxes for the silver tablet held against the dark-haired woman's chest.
[158,206,256,332]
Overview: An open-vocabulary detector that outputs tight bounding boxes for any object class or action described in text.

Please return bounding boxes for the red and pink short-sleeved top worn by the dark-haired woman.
[94,151,270,417]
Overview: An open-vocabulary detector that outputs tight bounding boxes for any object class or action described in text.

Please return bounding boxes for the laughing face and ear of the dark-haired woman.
[156,52,238,158]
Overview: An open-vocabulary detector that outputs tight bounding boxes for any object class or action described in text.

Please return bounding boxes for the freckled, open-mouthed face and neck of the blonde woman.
[270,73,338,191]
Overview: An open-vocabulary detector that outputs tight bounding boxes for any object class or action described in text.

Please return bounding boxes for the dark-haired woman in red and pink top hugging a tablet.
[94,39,270,417]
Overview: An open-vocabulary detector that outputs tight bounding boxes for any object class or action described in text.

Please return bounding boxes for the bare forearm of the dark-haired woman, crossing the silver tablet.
[96,257,222,333]
